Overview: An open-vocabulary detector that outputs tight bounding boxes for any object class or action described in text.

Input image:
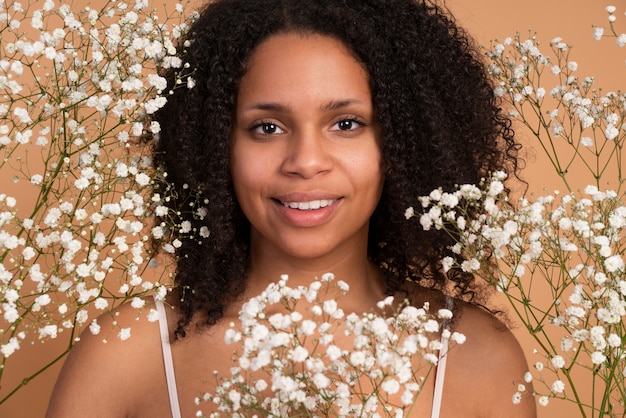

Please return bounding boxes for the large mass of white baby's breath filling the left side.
[0,0,194,403]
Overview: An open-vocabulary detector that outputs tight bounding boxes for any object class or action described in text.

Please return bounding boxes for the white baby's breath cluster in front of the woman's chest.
[197,274,465,417]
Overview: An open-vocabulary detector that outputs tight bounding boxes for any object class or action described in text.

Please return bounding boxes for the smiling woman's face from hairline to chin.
[231,33,383,259]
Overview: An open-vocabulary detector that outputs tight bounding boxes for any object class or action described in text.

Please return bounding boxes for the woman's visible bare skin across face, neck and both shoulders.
[48,33,535,418]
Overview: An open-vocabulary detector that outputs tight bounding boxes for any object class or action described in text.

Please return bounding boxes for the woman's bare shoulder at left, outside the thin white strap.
[47,299,164,418]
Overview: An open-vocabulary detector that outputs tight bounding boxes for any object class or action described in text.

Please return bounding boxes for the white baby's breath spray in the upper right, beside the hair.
[487,7,626,192]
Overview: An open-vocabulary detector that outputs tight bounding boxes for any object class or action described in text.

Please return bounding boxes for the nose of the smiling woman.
[282,130,333,178]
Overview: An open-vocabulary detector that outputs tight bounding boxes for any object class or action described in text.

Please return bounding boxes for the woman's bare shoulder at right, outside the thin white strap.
[446,303,536,418]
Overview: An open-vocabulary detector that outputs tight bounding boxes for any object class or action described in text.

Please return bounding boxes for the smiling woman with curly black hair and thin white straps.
[48,0,535,418]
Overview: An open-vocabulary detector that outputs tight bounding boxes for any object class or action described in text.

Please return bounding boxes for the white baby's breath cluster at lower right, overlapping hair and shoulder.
[407,173,626,416]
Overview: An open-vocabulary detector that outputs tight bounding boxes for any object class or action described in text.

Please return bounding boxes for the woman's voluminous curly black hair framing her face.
[154,0,519,336]
